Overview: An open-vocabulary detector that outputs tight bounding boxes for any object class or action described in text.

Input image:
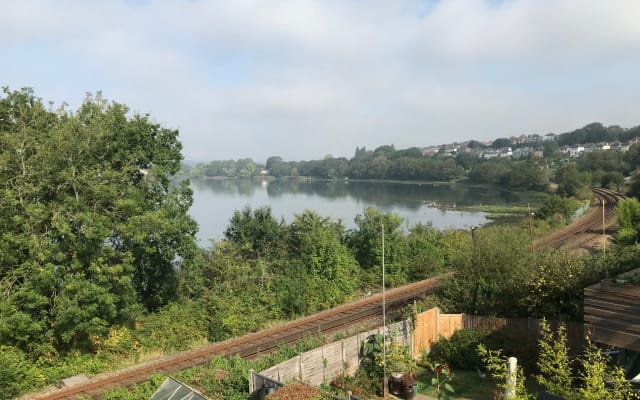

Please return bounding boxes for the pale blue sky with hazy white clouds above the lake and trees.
[0,0,640,163]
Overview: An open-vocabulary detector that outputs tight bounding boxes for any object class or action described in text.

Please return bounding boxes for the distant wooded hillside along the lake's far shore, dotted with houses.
[182,123,640,196]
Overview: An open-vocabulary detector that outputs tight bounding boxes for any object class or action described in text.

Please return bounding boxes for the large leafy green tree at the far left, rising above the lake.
[0,88,197,353]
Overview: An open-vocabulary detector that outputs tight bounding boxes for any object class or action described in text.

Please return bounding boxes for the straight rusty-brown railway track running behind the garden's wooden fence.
[28,278,439,400]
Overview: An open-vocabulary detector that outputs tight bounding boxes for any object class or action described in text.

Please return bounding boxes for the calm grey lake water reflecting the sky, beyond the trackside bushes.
[190,179,536,246]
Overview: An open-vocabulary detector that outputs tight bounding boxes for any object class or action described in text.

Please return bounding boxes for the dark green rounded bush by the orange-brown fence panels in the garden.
[430,329,489,371]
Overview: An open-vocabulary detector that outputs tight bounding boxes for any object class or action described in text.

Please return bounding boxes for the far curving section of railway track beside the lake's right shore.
[534,188,626,251]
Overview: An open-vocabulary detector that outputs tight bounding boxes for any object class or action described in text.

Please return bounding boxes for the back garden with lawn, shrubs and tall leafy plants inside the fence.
[324,320,639,400]
